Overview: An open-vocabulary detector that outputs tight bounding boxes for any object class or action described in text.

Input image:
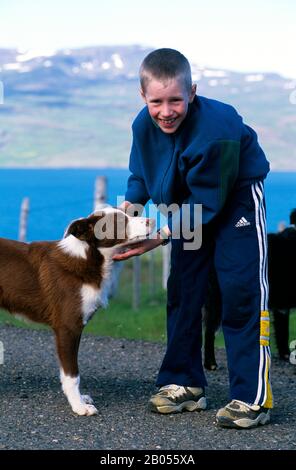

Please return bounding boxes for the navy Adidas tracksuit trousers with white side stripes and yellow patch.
[157,181,272,408]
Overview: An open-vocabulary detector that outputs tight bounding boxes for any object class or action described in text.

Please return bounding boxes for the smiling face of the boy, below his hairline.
[141,77,196,134]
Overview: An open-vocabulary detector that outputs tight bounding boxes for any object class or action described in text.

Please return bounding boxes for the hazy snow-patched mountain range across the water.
[0,46,296,170]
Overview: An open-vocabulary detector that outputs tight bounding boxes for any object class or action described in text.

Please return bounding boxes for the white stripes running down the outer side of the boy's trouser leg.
[252,182,270,405]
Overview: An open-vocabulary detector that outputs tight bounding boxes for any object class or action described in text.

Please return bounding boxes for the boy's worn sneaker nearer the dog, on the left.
[148,384,207,413]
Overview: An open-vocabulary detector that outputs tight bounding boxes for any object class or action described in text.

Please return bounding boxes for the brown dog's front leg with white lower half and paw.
[55,328,98,416]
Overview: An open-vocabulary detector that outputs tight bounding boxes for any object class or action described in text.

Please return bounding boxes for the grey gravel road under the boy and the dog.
[0,326,296,450]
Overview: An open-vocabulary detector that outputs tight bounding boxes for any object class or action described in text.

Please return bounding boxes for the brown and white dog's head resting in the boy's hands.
[64,207,155,248]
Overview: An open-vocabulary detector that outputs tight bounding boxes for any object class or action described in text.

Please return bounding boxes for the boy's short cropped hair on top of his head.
[140,48,192,92]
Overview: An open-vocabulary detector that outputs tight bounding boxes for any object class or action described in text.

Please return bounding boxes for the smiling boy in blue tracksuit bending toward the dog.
[115,49,272,428]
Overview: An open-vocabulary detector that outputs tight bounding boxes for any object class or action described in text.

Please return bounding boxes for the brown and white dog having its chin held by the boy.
[0,208,154,415]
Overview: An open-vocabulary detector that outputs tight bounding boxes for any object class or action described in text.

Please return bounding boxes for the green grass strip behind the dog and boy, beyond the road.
[0,249,296,352]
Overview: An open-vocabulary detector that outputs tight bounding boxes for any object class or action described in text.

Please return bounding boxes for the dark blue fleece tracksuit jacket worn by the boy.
[125,96,269,223]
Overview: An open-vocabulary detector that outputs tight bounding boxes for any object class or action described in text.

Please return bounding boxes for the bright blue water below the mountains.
[0,169,296,241]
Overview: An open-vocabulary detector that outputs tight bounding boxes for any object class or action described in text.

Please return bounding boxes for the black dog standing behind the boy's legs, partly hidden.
[203,231,296,370]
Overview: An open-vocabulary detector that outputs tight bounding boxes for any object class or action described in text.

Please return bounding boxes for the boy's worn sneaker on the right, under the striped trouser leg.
[216,400,270,429]
